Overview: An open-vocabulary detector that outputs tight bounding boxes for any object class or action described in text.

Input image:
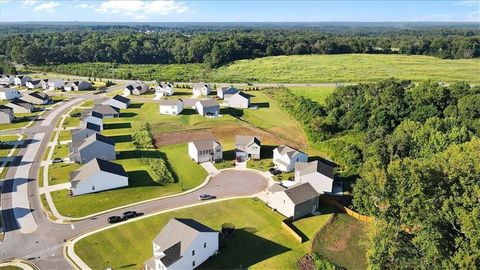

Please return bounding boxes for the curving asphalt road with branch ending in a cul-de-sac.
[0,89,267,269]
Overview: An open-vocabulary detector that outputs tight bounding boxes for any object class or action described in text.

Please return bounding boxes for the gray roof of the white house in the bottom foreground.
[153,218,216,267]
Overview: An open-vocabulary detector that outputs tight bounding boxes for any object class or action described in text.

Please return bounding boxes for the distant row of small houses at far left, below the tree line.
[0,75,92,92]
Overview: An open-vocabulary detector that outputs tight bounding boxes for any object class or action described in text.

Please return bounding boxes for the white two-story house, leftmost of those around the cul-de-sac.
[188,140,223,163]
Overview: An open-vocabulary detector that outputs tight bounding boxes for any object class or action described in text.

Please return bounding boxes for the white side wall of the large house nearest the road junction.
[72,172,128,195]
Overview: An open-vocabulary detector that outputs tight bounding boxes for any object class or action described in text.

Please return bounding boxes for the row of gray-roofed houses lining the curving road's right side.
[69,95,130,196]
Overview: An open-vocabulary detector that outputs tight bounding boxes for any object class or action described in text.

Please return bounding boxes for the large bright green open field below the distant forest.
[211,54,480,83]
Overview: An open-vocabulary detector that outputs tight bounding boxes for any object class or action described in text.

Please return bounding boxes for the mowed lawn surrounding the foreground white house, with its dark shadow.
[75,199,334,269]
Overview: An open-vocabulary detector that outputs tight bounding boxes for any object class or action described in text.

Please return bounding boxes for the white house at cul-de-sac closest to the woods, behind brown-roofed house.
[295,160,333,194]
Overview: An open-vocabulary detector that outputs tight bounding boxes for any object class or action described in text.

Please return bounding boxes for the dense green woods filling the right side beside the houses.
[269,79,480,269]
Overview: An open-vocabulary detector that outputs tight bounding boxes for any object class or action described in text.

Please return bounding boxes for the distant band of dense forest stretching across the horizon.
[0,25,480,67]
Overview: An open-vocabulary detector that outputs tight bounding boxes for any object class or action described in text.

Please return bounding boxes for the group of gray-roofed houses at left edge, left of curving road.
[0,88,52,124]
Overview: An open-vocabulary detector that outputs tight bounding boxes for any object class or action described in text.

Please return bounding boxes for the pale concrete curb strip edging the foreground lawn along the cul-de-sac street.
[63,195,255,270]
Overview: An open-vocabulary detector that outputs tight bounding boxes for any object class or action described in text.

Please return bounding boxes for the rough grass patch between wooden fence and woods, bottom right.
[312,214,369,269]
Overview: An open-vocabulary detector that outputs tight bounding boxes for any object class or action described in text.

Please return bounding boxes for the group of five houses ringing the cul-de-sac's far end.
[188,136,333,220]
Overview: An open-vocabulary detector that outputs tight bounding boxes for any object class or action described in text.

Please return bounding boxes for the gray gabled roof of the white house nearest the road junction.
[70,158,128,187]
